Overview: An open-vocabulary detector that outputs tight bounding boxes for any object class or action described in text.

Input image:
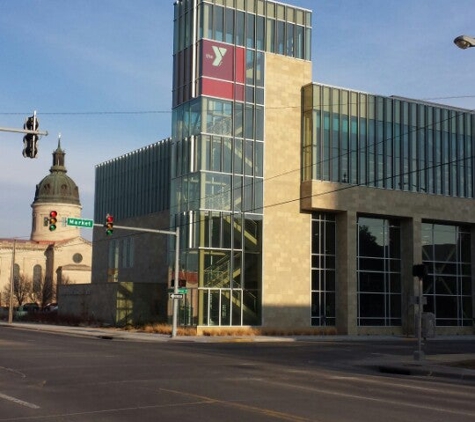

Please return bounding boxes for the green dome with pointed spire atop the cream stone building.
[34,141,81,205]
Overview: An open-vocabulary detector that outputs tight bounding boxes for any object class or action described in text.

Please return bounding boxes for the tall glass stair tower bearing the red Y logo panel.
[170,0,311,326]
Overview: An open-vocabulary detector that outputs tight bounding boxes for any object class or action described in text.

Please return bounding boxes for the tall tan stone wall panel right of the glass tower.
[262,53,312,327]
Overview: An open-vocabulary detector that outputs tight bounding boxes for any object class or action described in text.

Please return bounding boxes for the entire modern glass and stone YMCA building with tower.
[82,0,475,335]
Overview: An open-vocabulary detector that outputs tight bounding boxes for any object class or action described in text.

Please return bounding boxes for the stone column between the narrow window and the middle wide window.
[335,212,358,335]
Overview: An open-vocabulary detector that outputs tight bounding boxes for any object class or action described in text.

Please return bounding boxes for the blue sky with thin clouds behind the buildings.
[0,0,475,238]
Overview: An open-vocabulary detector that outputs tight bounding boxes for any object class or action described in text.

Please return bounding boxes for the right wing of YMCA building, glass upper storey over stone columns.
[302,84,475,331]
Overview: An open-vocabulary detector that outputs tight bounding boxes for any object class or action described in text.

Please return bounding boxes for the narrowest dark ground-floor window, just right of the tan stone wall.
[311,213,336,326]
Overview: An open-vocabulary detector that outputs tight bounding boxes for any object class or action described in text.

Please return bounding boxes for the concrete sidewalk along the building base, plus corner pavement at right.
[0,322,475,383]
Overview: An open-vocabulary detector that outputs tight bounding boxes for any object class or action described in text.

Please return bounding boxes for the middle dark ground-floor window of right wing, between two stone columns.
[357,217,402,326]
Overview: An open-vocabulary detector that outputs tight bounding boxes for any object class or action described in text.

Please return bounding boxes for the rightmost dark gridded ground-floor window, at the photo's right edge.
[422,223,473,327]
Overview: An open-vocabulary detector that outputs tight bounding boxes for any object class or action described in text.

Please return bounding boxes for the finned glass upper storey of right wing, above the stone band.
[302,84,475,198]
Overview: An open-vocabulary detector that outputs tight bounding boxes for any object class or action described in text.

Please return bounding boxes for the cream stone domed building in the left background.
[0,139,92,306]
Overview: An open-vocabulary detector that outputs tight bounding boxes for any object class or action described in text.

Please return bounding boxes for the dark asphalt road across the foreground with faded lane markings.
[0,327,475,422]
